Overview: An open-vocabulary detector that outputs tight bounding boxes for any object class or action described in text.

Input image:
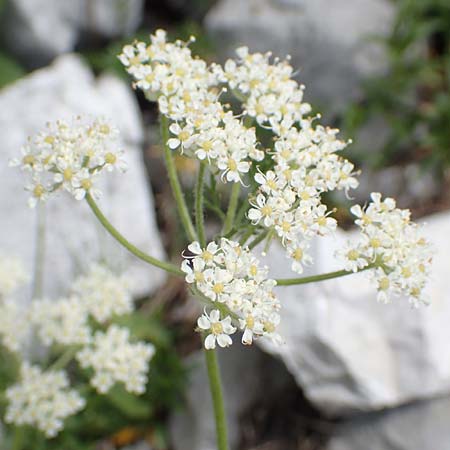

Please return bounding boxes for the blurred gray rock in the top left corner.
[1,0,143,67]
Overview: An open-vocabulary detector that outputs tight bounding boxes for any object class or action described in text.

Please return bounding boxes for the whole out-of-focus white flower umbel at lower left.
[0,257,155,437]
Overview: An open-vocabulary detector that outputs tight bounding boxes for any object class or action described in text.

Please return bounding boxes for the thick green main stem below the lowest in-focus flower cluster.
[204,349,228,450]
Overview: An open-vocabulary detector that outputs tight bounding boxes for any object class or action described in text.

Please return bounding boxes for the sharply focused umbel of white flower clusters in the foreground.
[14,30,431,358]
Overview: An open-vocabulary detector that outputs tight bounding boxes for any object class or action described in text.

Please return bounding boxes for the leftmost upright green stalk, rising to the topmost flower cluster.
[160,114,197,241]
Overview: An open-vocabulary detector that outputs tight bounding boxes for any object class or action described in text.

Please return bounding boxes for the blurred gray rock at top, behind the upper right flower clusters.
[205,0,394,114]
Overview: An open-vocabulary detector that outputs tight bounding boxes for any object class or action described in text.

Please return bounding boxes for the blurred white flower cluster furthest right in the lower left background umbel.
[76,325,155,394]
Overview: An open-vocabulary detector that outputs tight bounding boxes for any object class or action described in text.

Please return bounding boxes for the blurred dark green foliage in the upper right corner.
[343,0,450,173]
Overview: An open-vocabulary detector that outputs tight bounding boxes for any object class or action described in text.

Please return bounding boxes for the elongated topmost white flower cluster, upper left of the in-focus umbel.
[119,30,264,182]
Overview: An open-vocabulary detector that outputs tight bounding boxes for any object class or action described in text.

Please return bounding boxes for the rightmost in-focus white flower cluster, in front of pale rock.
[338,193,432,305]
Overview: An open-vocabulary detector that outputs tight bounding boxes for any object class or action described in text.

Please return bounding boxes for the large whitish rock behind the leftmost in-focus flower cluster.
[0,55,165,296]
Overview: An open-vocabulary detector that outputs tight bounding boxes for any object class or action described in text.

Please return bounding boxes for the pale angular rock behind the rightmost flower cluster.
[261,213,450,415]
